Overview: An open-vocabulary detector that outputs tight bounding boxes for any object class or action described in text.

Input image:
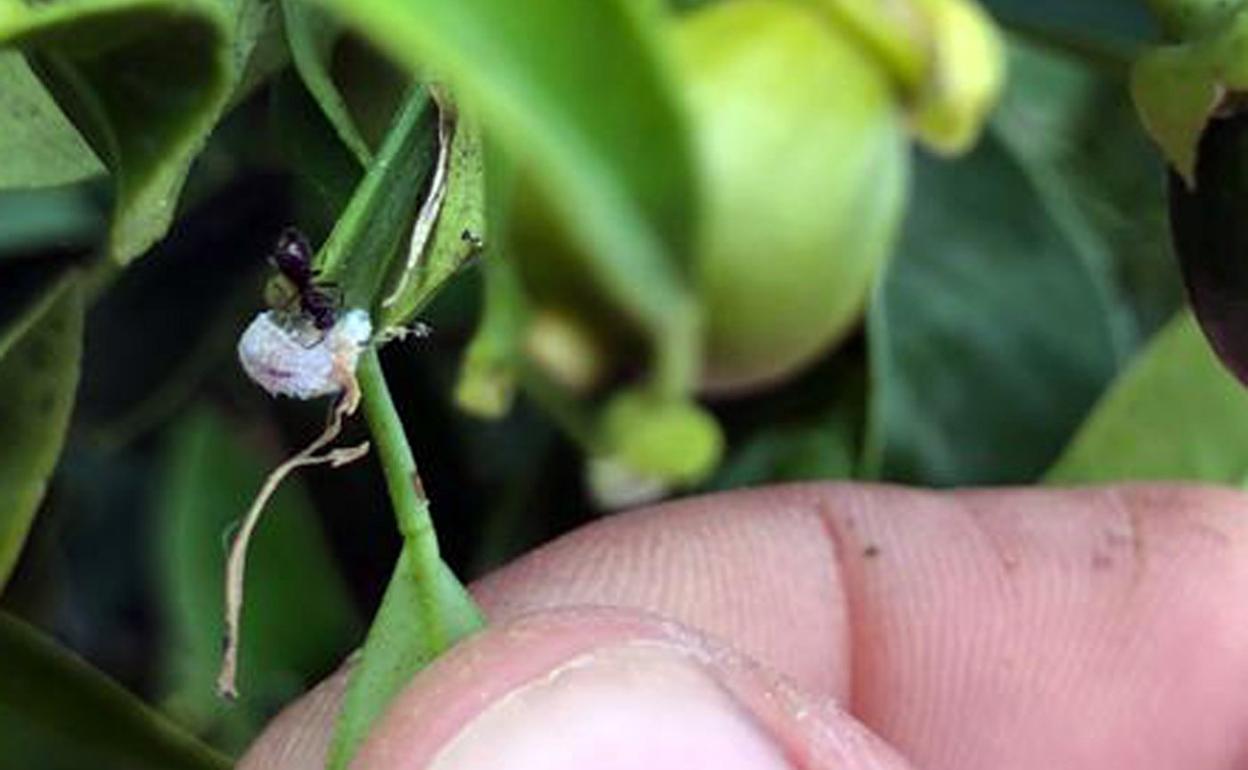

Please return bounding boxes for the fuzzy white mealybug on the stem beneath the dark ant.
[238,309,373,401]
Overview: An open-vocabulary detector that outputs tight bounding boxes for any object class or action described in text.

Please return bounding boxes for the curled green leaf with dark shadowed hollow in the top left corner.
[0,0,233,263]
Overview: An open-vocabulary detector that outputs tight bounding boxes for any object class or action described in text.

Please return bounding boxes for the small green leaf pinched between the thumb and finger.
[327,544,483,770]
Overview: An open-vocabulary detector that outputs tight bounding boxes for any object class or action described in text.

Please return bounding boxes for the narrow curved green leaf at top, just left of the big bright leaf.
[282,0,373,166]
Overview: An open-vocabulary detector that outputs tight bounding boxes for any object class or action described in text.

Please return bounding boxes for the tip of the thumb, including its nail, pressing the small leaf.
[357,610,906,770]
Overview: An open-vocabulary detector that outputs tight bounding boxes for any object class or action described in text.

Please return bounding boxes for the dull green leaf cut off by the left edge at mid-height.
[0,271,84,588]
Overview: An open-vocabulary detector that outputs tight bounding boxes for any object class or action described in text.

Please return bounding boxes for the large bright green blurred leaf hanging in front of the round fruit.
[309,0,696,394]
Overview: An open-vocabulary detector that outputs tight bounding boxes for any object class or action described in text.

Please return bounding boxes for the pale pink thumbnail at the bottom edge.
[429,643,791,770]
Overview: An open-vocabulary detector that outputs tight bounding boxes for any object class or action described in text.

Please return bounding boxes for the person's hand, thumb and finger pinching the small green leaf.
[240,484,1248,770]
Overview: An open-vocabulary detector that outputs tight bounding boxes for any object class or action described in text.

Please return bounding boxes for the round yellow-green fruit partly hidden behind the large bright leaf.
[675,0,907,391]
